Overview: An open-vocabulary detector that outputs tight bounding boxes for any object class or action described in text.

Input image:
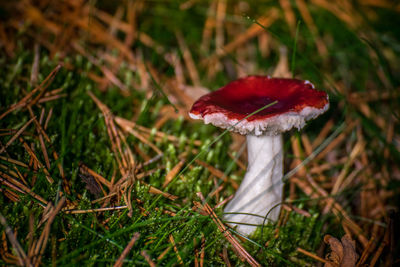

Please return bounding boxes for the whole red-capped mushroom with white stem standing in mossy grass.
[189,76,329,235]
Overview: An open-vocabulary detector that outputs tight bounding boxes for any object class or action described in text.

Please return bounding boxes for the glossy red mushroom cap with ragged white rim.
[189,76,329,135]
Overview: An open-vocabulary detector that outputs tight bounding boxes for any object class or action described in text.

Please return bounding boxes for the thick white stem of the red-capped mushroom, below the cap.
[224,134,283,235]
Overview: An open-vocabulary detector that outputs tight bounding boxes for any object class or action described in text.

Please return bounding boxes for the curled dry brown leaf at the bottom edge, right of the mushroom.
[324,235,358,267]
